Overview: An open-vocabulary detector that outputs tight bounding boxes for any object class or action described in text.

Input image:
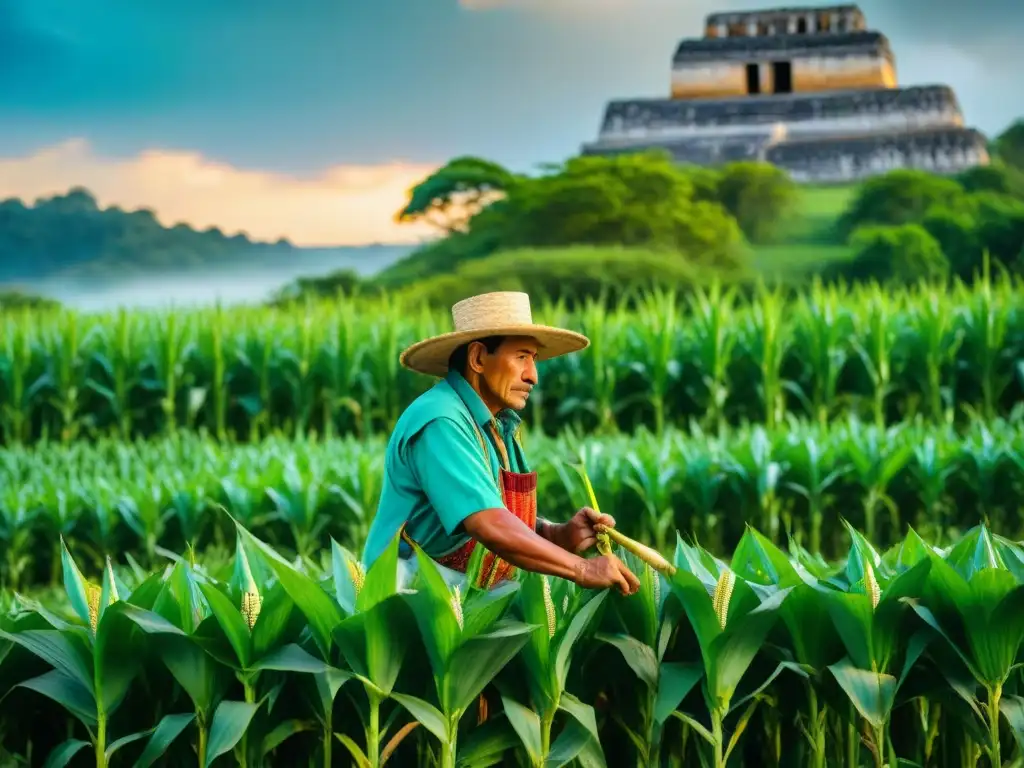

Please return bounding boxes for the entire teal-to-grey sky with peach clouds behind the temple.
[0,0,1024,246]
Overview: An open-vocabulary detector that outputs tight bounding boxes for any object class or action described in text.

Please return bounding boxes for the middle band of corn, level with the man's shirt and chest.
[6,419,1024,590]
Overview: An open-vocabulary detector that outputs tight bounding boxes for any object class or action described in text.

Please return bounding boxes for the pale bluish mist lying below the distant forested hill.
[16,246,413,312]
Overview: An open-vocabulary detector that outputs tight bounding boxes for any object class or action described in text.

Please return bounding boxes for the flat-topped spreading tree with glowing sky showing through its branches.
[395,157,518,234]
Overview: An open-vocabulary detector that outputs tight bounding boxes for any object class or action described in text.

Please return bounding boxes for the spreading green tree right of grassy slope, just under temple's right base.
[838,170,967,238]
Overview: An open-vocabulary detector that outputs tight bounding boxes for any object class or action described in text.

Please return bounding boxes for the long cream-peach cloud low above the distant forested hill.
[0,139,436,246]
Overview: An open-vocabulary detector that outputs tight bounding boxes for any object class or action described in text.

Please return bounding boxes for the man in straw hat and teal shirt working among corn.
[364,293,640,595]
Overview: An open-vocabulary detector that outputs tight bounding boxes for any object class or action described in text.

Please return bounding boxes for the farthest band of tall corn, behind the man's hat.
[0,279,1024,445]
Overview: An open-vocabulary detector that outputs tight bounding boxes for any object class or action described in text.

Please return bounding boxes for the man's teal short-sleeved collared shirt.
[362,373,529,566]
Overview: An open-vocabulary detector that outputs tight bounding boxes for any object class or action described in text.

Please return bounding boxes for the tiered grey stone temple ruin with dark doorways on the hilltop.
[583,5,989,183]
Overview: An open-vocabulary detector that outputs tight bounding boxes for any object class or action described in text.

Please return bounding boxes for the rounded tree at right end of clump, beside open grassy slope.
[718,163,799,243]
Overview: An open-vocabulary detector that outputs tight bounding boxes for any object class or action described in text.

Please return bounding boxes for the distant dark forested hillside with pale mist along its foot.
[0,188,411,308]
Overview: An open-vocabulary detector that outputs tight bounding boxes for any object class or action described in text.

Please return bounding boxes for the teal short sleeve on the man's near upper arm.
[409,418,505,536]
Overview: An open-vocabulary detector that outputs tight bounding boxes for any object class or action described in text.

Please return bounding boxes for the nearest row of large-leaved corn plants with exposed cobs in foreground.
[6,521,1024,768]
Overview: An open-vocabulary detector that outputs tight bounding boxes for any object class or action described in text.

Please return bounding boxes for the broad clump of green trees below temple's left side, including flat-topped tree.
[372,152,797,288]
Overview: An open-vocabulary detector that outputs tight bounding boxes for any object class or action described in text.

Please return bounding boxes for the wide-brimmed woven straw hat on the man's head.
[398,291,590,378]
